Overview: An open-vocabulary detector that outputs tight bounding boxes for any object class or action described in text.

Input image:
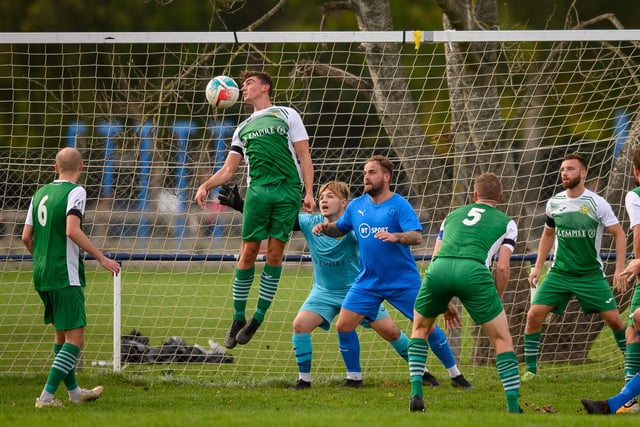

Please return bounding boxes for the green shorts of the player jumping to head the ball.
[242,182,301,242]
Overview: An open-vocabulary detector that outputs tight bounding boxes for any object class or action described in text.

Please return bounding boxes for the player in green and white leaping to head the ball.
[195,71,315,348]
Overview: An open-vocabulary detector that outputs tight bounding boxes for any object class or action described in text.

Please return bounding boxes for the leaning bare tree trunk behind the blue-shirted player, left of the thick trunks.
[294,0,450,221]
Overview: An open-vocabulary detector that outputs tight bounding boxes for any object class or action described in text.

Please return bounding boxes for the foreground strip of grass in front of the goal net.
[0,367,638,427]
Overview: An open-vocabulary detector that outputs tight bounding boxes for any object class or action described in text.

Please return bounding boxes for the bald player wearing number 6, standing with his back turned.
[22,147,120,408]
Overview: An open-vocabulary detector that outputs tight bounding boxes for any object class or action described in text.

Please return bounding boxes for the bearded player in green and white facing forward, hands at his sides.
[522,154,627,381]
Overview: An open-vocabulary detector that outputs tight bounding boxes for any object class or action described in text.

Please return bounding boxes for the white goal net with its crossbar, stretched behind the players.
[0,30,640,379]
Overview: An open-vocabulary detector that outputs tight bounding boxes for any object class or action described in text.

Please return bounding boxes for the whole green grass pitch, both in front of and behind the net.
[0,268,640,427]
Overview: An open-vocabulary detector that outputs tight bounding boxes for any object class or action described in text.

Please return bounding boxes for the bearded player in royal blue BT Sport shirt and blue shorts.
[312,156,473,389]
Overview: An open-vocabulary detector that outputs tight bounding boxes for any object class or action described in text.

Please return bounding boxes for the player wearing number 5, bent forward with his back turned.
[409,173,521,413]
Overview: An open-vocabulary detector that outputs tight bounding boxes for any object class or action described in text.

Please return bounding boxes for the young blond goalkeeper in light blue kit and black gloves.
[219,181,471,390]
